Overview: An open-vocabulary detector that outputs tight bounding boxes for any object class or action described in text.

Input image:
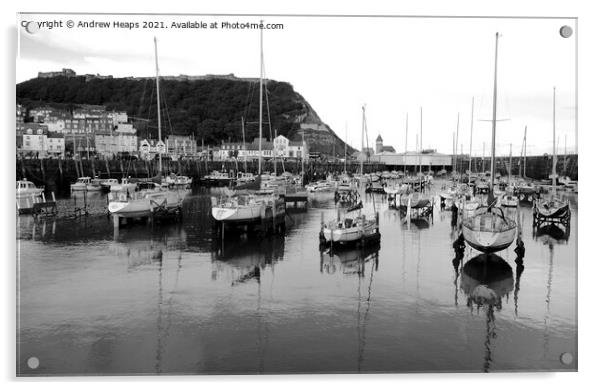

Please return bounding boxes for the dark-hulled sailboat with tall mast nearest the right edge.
[533,87,570,224]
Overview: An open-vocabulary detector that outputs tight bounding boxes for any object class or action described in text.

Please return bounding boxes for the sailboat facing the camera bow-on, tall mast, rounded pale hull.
[462,33,516,253]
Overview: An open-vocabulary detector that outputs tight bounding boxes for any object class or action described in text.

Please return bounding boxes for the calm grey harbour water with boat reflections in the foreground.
[17,184,577,375]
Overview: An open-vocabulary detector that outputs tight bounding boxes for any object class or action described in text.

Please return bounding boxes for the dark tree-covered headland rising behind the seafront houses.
[16,75,353,156]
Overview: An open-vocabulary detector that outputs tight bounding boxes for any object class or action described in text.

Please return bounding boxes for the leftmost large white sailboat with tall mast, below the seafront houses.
[108,38,183,218]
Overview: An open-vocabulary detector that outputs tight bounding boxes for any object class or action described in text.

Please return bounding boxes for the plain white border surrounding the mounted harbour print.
[0,0,602,390]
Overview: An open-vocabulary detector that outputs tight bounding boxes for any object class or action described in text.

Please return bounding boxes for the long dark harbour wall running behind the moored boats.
[16,155,578,193]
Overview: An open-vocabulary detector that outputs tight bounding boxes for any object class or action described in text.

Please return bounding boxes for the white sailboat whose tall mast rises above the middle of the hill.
[211,19,285,223]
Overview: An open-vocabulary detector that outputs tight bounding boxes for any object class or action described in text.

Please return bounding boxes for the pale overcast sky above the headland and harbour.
[16,15,576,156]
